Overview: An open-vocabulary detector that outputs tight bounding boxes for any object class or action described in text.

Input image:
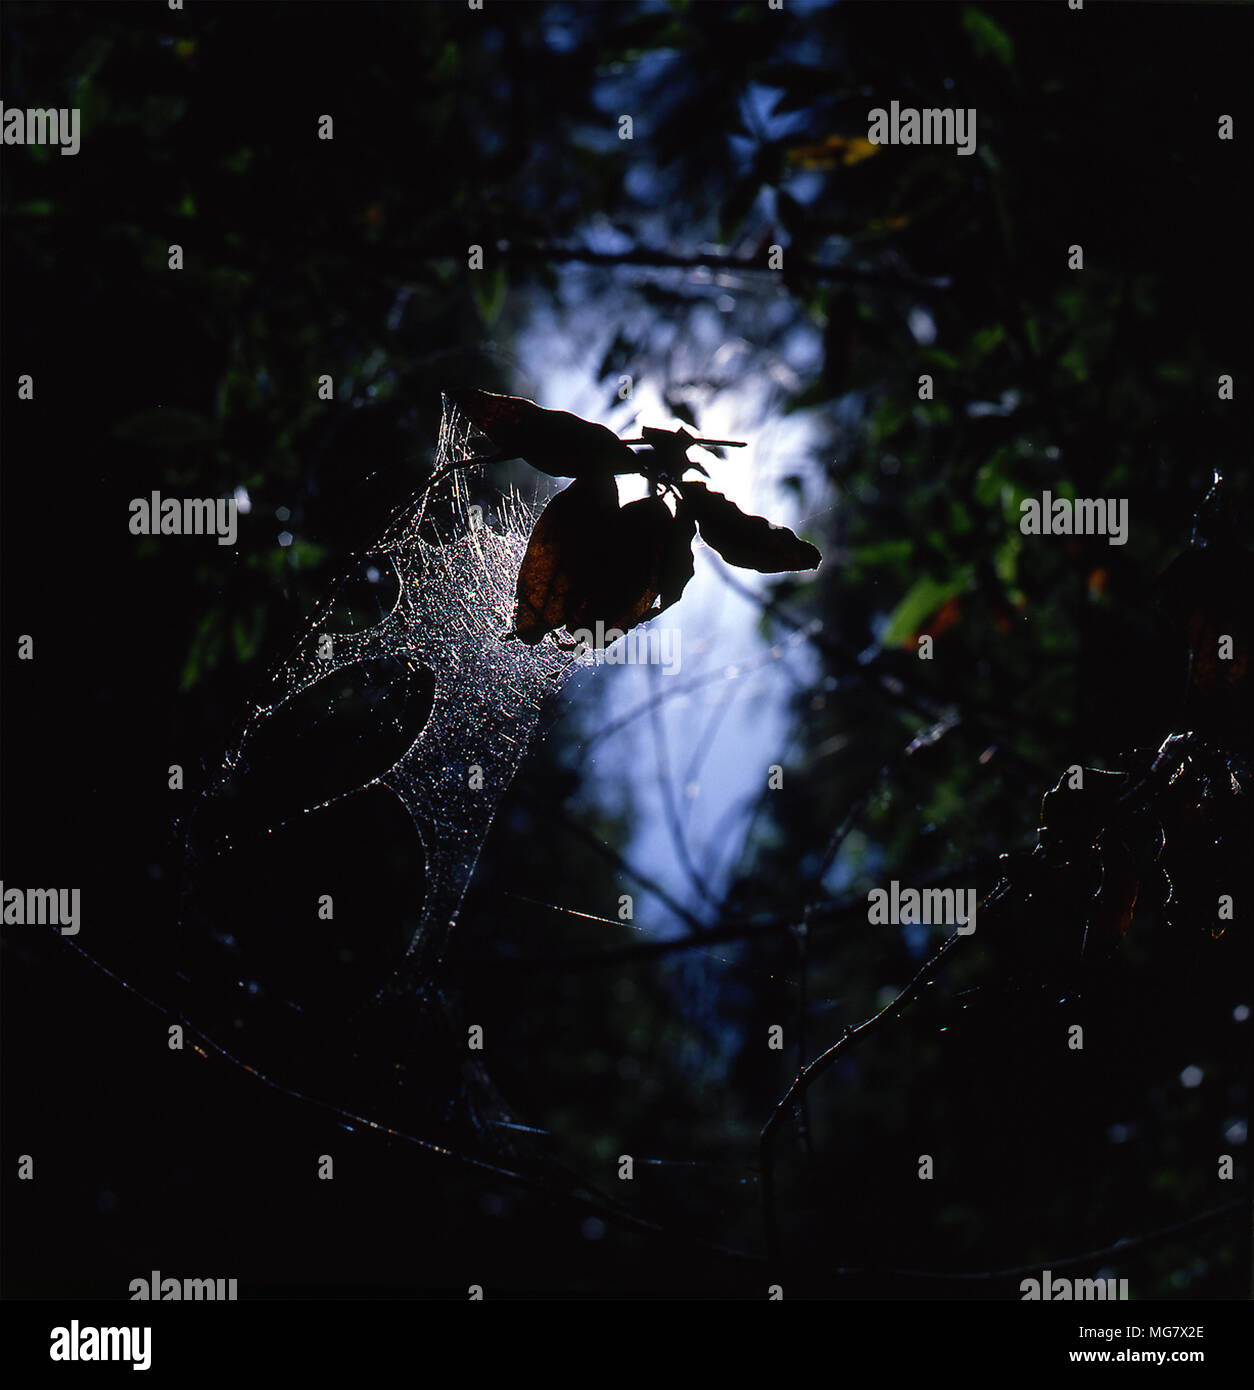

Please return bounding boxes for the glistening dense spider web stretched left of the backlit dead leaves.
[218,402,577,984]
